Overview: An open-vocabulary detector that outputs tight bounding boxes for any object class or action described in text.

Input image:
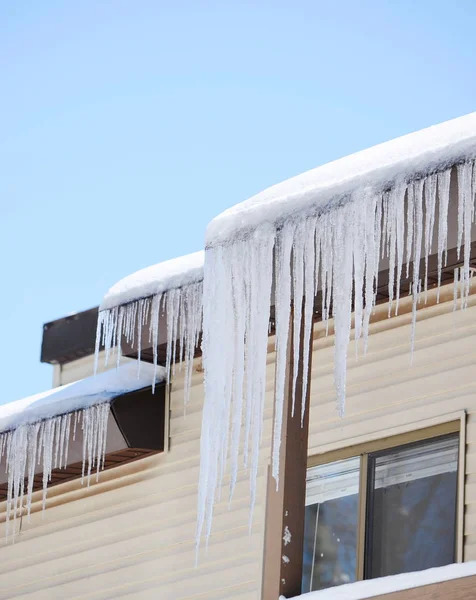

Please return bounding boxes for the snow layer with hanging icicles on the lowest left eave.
[0,363,165,535]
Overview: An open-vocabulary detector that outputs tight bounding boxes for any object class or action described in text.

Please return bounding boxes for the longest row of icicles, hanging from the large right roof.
[197,160,476,545]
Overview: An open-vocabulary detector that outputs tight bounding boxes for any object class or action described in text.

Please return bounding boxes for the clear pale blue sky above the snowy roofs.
[0,0,476,403]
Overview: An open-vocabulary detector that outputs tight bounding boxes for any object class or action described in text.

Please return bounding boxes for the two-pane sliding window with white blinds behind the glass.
[302,424,459,593]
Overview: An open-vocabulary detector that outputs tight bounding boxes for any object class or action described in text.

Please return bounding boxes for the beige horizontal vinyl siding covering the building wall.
[0,287,476,600]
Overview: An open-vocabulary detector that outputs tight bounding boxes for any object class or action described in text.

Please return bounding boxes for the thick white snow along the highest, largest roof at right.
[206,112,476,246]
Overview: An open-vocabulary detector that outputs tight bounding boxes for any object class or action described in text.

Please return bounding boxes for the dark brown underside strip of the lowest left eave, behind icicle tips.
[0,448,159,502]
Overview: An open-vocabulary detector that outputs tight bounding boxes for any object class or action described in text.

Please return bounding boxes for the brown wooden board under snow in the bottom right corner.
[372,575,476,600]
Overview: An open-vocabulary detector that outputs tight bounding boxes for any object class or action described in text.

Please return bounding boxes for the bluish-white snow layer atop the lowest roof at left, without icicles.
[0,361,165,433]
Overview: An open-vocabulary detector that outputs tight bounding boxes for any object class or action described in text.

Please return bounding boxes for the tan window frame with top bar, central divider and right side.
[307,418,466,581]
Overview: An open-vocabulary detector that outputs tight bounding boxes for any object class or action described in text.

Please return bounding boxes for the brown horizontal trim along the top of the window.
[307,419,461,468]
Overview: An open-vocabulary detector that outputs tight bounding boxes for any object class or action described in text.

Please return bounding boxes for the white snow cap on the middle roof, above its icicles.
[99,250,204,310]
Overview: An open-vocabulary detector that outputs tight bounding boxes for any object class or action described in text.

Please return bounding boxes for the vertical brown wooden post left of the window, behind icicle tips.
[262,314,312,600]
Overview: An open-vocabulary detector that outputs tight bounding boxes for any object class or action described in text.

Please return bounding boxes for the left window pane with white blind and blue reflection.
[302,457,360,593]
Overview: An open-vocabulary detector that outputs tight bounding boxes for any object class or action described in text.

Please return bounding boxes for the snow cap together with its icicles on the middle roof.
[95,251,204,402]
